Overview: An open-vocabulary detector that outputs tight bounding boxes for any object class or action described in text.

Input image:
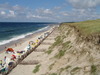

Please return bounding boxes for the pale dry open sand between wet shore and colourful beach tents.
[0,24,57,74]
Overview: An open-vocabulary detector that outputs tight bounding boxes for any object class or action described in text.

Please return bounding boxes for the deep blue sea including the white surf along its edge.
[0,22,48,45]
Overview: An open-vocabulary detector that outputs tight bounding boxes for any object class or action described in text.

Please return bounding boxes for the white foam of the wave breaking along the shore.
[0,26,49,45]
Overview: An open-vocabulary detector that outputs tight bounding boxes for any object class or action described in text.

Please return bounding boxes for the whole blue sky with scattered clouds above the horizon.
[0,0,100,22]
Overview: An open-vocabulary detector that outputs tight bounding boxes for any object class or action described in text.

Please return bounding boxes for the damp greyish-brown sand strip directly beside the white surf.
[0,25,51,54]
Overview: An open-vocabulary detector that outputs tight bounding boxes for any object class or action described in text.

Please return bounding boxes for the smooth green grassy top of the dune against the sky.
[62,19,100,35]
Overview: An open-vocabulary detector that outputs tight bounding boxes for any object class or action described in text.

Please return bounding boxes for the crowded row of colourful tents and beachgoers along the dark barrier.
[0,29,53,73]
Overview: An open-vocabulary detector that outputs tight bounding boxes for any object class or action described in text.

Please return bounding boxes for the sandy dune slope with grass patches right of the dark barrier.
[9,26,100,75]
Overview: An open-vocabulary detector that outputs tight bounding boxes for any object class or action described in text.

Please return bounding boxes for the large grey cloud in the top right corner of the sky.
[69,0,100,8]
